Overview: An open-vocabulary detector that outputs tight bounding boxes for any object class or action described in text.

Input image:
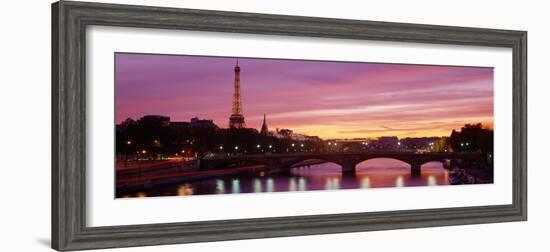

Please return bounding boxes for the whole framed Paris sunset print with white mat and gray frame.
[52,1,527,250]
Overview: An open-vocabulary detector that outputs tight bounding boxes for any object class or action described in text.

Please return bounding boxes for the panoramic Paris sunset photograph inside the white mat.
[115,52,494,198]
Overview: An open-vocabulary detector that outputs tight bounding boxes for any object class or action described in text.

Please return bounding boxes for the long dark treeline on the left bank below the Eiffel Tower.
[116,117,324,159]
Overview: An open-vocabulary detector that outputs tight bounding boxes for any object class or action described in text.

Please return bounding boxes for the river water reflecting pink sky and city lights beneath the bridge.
[118,158,449,197]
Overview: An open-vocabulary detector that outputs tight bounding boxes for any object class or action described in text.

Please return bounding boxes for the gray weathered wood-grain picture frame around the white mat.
[52,1,527,250]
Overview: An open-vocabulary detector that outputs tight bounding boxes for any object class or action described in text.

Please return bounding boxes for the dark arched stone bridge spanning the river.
[200,151,483,174]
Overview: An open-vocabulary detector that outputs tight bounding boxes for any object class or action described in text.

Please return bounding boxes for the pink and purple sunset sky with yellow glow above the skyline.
[115,53,493,139]
